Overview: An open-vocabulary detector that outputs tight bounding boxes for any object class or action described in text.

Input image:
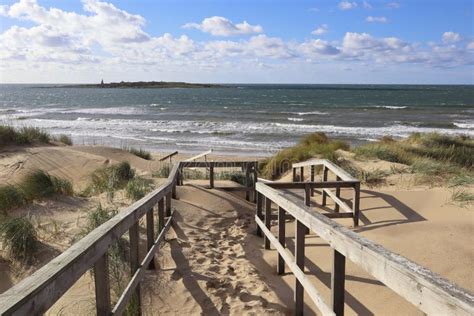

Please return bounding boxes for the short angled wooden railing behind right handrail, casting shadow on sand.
[292,159,360,227]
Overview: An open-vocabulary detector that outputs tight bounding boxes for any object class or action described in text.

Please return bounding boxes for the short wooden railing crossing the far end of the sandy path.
[178,161,258,201]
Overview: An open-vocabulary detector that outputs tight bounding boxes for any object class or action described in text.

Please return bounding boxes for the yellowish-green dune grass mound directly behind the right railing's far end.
[259,133,349,179]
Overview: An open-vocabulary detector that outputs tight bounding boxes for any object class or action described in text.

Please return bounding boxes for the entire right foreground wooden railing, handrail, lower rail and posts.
[255,182,474,315]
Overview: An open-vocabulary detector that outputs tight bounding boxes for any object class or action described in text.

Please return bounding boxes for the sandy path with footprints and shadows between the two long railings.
[142,185,289,315]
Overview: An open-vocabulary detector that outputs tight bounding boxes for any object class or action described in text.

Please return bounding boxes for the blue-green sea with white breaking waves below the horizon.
[0,85,474,155]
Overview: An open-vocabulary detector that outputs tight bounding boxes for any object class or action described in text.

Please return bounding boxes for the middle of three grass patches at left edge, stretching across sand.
[0,169,74,213]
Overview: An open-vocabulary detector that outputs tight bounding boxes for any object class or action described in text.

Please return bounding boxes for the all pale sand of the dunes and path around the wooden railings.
[0,142,474,315]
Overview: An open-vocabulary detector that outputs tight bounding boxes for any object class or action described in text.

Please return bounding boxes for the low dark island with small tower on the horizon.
[57,81,223,89]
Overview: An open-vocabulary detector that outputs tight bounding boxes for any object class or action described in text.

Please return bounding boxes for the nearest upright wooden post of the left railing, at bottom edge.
[94,252,111,316]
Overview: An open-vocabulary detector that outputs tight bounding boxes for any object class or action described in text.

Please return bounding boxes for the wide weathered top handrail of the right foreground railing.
[257,183,474,315]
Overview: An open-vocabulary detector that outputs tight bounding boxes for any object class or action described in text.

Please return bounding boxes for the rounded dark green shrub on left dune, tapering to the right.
[20,169,73,201]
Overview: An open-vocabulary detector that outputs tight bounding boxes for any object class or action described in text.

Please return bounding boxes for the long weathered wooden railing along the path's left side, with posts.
[0,164,179,315]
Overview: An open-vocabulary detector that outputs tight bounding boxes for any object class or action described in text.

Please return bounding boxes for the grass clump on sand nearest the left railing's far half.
[85,161,135,198]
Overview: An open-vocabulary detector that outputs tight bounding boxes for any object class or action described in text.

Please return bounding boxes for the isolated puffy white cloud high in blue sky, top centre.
[183,16,263,36]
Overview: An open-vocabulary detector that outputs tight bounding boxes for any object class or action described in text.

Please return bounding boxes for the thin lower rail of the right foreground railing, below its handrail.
[255,217,335,315]
